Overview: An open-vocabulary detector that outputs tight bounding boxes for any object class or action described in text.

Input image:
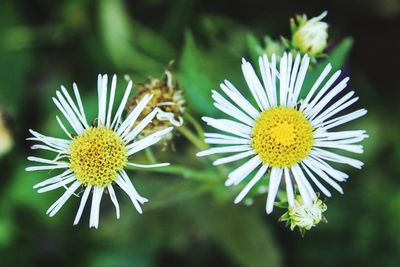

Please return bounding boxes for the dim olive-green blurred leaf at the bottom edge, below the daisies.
[196,205,281,267]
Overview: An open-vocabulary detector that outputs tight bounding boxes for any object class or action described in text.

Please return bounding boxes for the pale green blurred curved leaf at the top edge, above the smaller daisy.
[99,0,174,76]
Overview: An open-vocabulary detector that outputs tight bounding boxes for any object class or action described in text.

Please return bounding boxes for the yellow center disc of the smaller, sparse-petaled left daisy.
[69,128,128,186]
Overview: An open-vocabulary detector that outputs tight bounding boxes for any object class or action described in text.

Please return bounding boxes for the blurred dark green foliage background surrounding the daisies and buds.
[0,0,400,267]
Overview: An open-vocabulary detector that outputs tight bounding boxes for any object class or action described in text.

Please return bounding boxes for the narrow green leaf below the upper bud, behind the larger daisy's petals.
[300,37,353,99]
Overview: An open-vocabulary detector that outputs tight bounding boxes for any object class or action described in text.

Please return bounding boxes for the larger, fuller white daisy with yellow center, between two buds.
[197,53,367,213]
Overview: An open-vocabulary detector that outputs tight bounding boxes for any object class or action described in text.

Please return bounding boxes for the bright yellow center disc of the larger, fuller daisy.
[252,107,314,167]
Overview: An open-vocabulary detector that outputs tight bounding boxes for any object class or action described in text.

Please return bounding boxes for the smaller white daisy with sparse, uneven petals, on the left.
[26,75,172,228]
